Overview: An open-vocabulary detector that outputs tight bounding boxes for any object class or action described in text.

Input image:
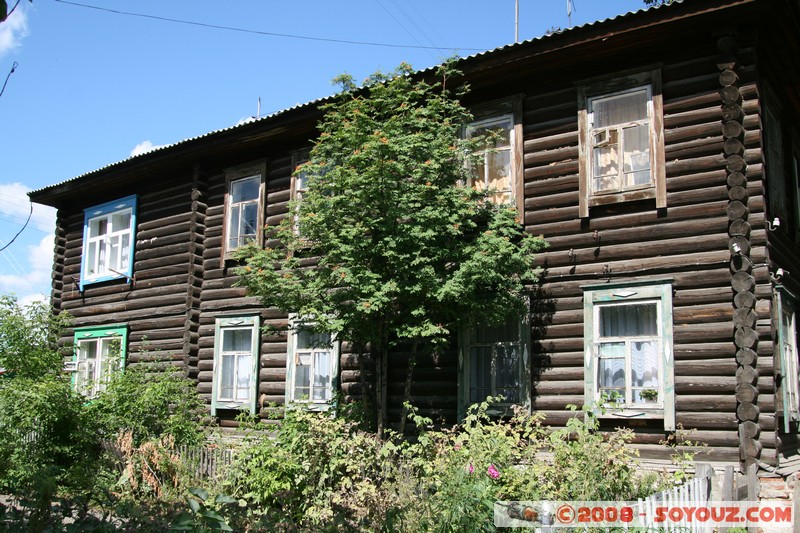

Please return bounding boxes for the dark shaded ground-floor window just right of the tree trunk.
[459,319,530,417]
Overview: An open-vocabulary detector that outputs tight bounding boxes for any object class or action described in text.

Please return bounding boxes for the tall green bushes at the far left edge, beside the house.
[0,297,99,530]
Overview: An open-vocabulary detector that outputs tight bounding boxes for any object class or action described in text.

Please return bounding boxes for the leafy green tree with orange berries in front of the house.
[240,64,544,434]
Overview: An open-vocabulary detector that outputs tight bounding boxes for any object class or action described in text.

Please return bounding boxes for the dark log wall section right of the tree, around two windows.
[500,37,775,461]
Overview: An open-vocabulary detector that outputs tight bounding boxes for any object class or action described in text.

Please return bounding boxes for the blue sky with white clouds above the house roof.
[0,0,645,303]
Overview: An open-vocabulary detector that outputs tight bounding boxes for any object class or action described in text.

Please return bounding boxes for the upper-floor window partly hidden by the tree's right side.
[464,97,523,213]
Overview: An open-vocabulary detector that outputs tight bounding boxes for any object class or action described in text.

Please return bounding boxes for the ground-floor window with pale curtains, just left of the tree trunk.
[286,324,339,409]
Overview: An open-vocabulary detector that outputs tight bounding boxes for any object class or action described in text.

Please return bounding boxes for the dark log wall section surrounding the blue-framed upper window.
[53,177,197,365]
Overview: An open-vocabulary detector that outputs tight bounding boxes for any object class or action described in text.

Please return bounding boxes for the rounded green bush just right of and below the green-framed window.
[86,363,205,445]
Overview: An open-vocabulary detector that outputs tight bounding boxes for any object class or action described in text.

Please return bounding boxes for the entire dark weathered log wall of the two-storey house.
[37,1,800,463]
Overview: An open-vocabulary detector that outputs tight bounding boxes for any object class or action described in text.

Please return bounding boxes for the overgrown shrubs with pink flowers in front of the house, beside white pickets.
[227,398,680,532]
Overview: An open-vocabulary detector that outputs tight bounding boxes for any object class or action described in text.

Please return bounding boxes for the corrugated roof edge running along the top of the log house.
[29,0,668,195]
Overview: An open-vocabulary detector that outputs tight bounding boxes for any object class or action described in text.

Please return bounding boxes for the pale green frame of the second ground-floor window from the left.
[211,315,261,416]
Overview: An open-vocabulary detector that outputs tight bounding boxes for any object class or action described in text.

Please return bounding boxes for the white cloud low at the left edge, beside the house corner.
[0,235,54,304]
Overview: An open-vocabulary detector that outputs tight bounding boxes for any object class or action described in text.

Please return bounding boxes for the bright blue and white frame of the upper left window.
[79,195,138,292]
